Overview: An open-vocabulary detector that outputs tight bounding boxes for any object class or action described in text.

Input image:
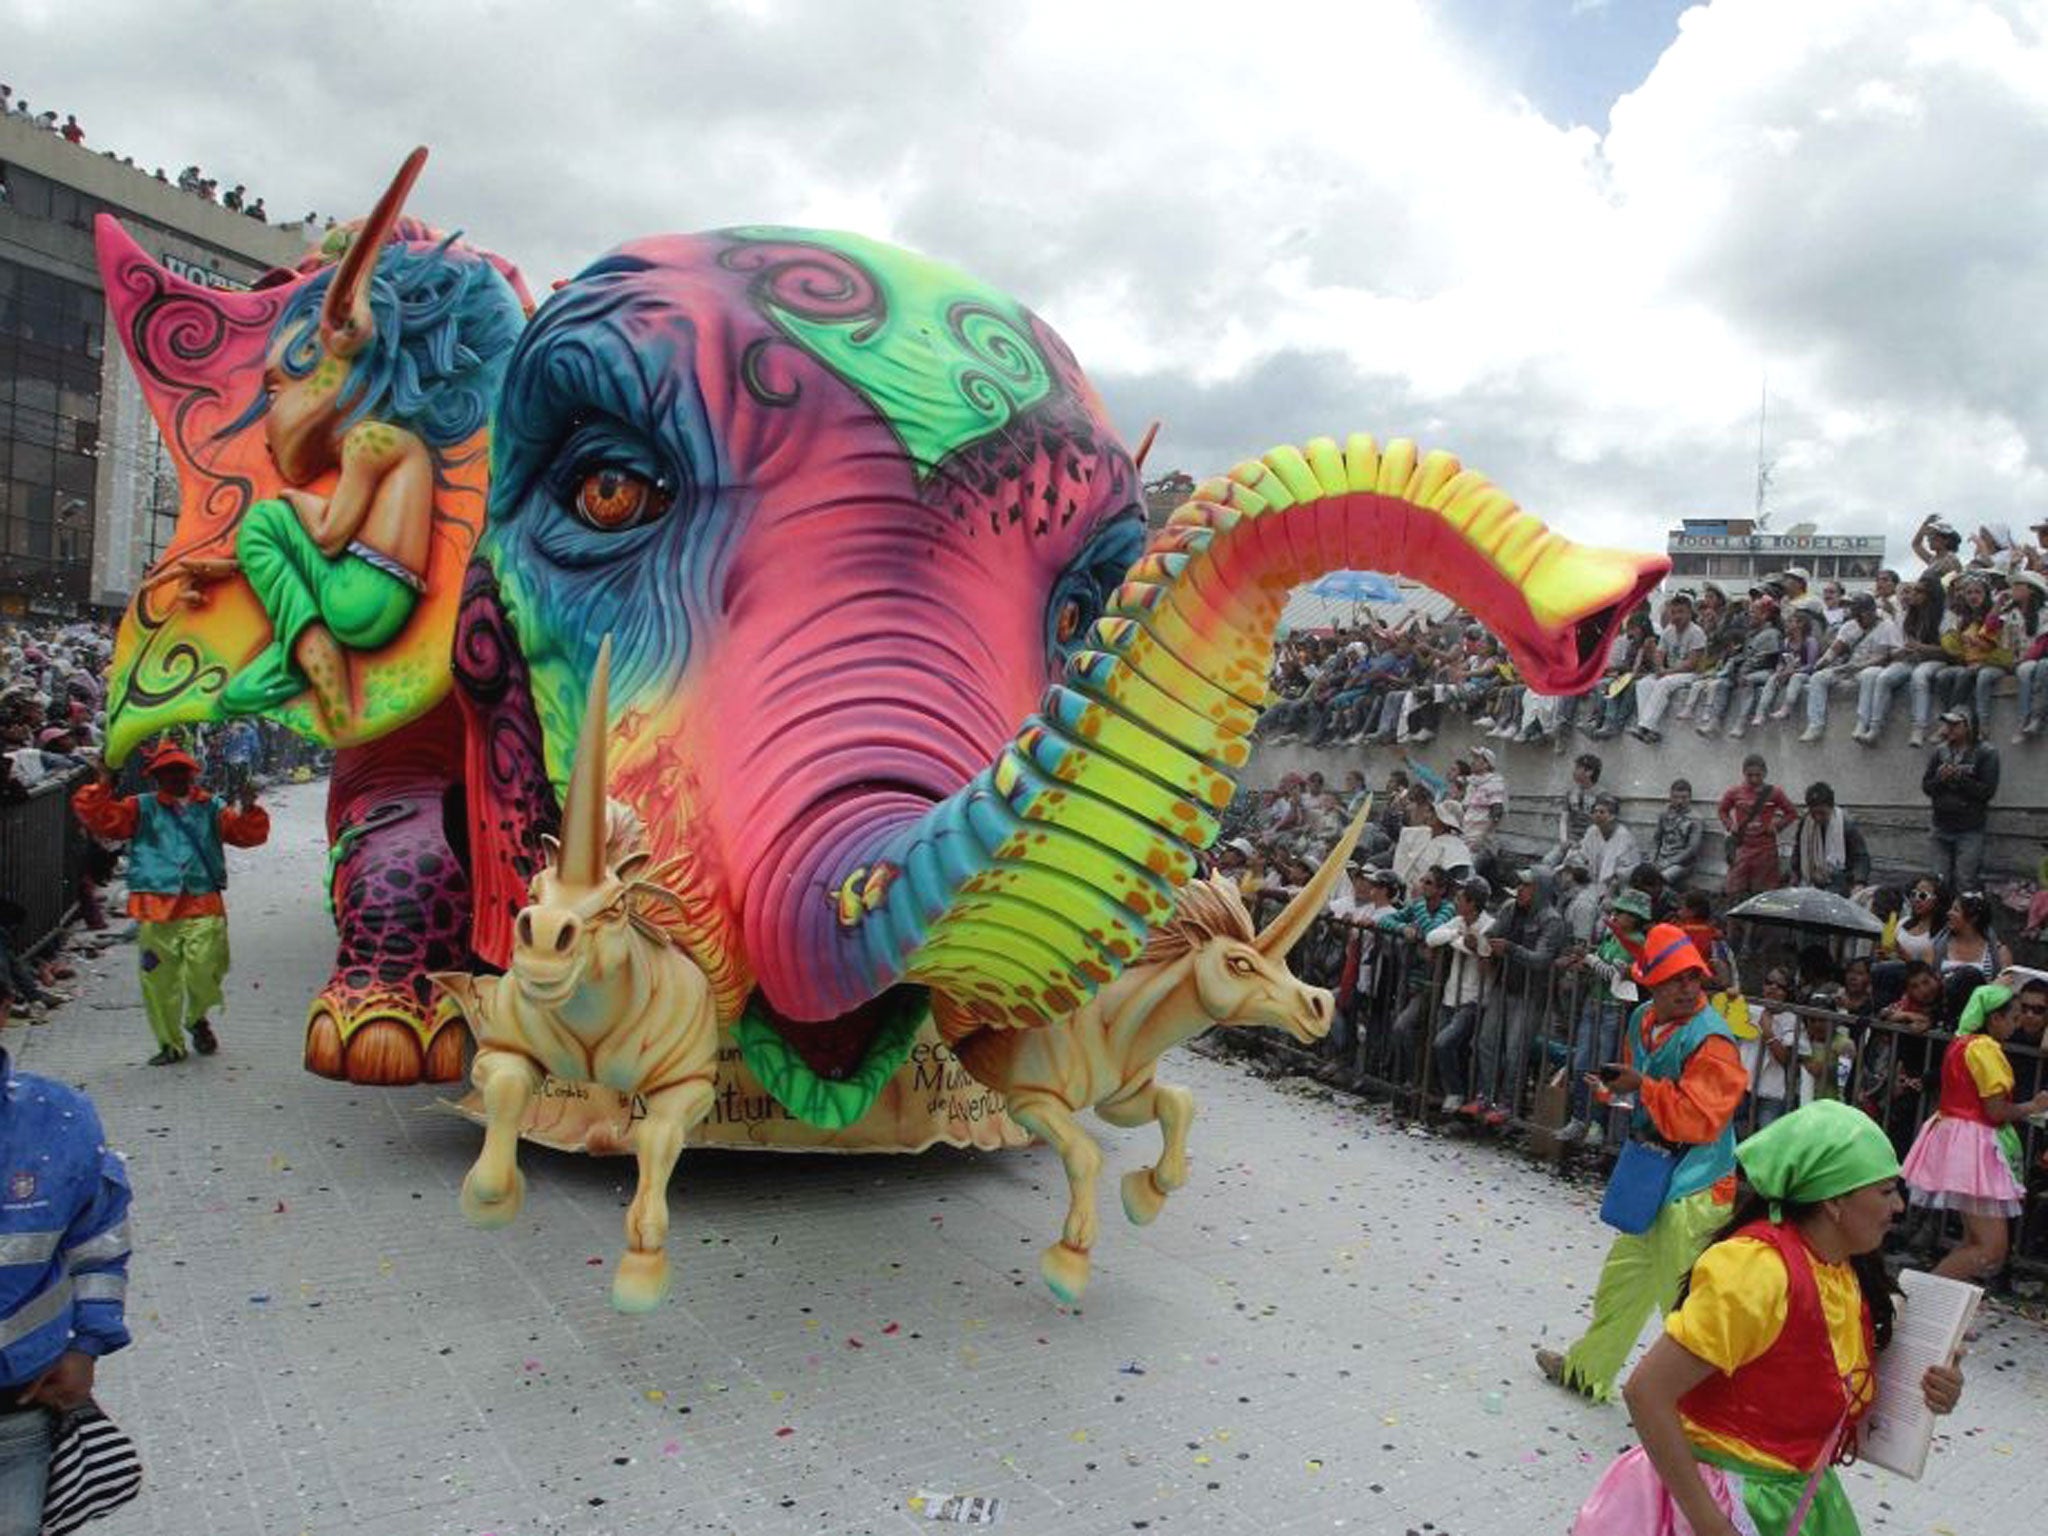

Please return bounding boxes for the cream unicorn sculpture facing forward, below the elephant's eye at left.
[434,639,719,1313]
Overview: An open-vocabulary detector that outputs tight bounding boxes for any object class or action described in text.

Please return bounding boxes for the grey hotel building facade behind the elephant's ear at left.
[0,117,307,616]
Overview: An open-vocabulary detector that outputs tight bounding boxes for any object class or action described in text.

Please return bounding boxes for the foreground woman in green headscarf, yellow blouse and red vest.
[1573,1100,1962,1536]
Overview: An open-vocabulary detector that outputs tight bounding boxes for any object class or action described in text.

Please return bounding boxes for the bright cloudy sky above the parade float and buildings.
[16,0,2048,561]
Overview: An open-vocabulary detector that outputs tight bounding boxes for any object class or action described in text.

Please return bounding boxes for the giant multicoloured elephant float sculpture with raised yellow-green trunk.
[100,150,1665,1141]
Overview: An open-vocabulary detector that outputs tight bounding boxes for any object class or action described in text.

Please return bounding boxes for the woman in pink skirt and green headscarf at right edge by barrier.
[1905,985,2048,1280]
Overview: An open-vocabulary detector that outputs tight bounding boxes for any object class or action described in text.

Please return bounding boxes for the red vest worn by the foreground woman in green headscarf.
[1677,1221,1878,1470]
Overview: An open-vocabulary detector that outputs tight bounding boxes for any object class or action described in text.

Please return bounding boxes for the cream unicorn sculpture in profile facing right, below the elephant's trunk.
[940,803,1372,1303]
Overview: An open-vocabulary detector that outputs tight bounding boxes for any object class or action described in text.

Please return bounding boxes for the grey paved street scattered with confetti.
[6,784,2048,1536]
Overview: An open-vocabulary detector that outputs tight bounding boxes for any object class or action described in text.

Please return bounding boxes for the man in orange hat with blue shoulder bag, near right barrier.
[1536,924,1749,1403]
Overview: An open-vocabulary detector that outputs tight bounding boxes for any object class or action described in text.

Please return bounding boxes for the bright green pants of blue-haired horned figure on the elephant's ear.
[221,502,420,715]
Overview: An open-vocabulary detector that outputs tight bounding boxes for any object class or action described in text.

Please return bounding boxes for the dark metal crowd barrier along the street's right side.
[1217,897,2048,1276]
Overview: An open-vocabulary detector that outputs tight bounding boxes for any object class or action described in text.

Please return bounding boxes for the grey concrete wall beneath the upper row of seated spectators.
[1247,698,2048,887]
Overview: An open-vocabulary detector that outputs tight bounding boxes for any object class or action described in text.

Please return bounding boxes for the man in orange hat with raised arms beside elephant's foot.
[72,741,270,1067]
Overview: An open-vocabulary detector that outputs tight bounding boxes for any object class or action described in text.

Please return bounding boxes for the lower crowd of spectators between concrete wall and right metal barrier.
[1214,729,2048,1174]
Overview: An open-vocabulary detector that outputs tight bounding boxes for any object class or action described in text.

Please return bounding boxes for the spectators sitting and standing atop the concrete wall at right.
[1260,518,2048,750]
